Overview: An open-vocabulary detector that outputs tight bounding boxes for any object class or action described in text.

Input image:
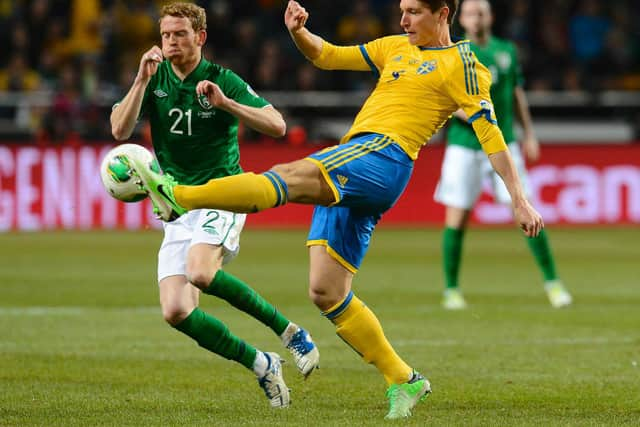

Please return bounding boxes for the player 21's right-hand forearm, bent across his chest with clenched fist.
[196,80,287,138]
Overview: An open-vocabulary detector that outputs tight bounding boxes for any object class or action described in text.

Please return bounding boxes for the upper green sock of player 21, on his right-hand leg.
[203,270,289,335]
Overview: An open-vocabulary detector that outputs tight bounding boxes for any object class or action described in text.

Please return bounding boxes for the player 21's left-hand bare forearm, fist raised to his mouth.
[110,46,162,141]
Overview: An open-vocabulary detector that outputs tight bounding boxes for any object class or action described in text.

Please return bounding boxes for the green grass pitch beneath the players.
[0,228,640,426]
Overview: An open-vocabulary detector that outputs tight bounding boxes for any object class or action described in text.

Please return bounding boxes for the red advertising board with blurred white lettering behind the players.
[0,144,640,230]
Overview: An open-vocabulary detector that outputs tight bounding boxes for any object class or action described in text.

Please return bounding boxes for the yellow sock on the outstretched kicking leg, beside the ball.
[173,171,287,213]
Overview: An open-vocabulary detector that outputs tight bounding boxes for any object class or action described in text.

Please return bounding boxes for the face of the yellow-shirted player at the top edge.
[400,0,446,46]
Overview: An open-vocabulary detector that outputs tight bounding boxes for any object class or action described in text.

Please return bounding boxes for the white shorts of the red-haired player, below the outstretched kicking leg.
[158,209,247,283]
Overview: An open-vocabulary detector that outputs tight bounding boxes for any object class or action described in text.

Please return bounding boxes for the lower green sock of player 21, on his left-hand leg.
[174,307,257,369]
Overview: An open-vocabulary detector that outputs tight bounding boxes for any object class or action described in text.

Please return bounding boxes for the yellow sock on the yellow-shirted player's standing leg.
[322,292,413,384]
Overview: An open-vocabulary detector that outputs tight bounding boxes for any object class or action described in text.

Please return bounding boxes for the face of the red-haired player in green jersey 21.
[160,16,206,65]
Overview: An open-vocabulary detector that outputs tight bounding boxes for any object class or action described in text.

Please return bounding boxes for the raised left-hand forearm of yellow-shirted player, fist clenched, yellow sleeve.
[284,0,372,71]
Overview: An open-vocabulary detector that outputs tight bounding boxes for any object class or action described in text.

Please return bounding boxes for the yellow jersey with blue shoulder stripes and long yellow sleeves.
[312,35,506,160]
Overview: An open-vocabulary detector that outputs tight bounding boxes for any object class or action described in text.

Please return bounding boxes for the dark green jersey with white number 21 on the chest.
[141,58,269,185]
